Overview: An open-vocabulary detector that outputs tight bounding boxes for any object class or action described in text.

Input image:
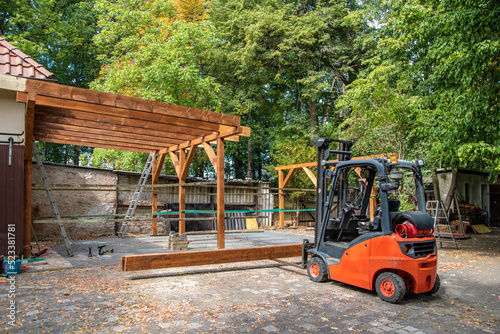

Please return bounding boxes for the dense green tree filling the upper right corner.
[340,0,500,173]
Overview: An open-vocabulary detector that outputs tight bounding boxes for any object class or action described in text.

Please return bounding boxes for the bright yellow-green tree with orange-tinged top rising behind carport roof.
[92,0,220,110]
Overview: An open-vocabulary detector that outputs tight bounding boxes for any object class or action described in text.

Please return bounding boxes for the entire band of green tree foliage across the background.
[6,0,500,183]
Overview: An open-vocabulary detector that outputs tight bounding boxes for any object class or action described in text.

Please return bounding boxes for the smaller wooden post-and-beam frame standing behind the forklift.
[274,154,395,227]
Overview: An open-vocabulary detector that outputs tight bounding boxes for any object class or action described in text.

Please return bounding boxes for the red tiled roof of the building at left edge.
[0,37,55,79]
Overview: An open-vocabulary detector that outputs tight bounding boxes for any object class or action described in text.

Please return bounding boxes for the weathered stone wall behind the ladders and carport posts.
[31,163,273,241]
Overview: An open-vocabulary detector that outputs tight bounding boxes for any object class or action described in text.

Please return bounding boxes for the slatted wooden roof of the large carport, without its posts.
[17,79,250,153]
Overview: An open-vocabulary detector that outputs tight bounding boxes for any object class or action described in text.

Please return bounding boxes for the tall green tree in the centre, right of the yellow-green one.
[206,0,376,183]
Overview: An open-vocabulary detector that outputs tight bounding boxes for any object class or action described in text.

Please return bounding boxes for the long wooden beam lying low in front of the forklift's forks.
[121,244,302,271]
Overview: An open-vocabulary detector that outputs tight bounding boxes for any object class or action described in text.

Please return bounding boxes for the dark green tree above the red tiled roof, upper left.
[0,0,99,165]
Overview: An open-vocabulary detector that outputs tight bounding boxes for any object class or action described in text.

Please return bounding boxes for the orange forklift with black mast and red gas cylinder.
[302,138,440,303]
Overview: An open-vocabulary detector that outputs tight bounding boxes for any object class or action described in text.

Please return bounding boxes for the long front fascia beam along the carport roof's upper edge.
[22,79,240,126]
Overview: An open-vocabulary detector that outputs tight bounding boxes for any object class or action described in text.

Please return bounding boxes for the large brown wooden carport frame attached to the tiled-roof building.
[10,76,250,257]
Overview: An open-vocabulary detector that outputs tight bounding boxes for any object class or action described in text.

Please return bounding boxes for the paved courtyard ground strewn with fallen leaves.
[0,231,500,334]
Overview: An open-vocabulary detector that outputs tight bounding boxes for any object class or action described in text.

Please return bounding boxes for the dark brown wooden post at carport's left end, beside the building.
[23,93,36,259]
